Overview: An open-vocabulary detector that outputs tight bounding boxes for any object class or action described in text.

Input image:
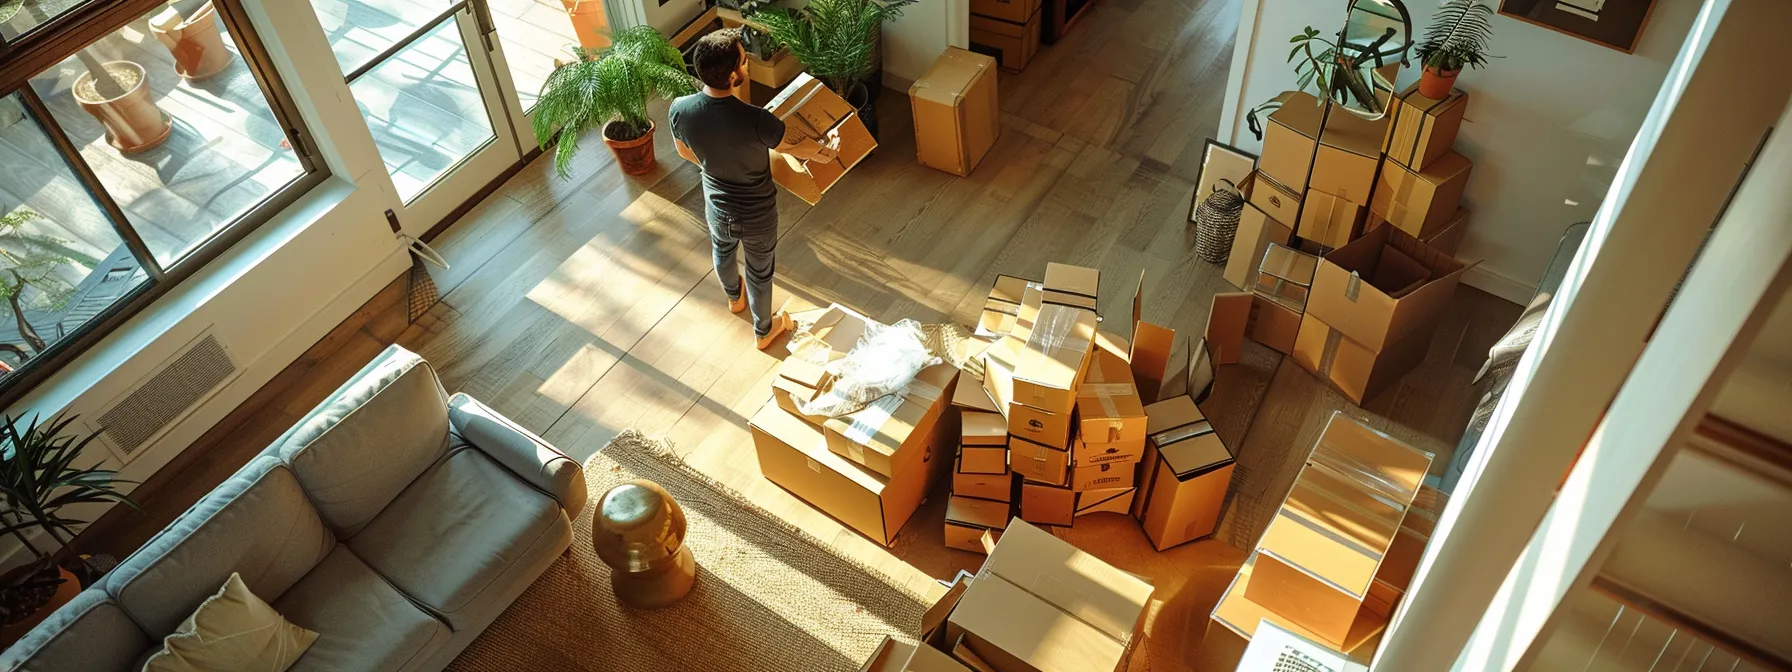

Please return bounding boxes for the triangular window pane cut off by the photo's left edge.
[0,93,149,380]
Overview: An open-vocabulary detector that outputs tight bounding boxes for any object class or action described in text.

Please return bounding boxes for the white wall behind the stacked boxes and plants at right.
[1220,0,1699,303]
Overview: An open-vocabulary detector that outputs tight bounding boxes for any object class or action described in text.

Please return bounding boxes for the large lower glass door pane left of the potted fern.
[349,18,496,201]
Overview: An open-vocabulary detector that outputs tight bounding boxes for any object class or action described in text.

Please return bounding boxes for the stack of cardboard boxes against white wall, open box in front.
[1215,86,1471,403]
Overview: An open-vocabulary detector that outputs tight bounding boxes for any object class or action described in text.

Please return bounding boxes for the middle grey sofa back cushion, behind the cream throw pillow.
[100,455,335,640]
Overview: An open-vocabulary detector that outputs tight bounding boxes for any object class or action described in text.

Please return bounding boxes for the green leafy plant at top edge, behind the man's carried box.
[756,0,918,95]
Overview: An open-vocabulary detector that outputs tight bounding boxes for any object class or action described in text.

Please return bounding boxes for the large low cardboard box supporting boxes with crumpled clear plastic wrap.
[747,400,944,547]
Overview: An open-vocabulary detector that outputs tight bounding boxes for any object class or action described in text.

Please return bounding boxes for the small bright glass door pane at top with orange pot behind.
[489,0,594,109]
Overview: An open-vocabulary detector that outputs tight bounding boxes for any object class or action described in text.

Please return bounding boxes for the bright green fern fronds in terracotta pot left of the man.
[532,25,697,177]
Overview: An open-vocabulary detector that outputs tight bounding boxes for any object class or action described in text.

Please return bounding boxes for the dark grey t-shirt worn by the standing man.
[667,91,785,226]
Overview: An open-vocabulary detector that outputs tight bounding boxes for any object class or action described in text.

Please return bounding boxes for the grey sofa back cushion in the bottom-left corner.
[0,588,154,672]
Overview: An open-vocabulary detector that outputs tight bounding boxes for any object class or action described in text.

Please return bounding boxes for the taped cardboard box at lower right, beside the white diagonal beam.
[1206,412,1439,659]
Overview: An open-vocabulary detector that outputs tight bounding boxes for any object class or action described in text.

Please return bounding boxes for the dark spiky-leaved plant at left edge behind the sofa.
[0,416,136,634]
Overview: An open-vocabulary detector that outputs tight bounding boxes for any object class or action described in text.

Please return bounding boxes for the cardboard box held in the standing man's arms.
[765,72,878,204]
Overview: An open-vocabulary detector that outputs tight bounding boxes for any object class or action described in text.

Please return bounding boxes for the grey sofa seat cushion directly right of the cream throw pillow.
[274,545,453,672]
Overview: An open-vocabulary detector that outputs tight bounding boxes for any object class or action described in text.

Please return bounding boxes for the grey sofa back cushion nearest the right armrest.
[269,346,448,538]
